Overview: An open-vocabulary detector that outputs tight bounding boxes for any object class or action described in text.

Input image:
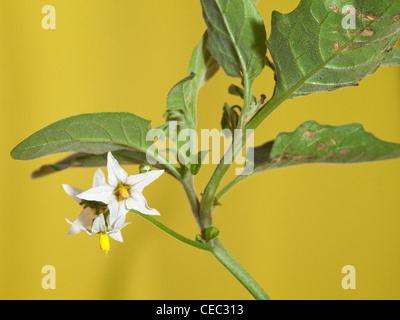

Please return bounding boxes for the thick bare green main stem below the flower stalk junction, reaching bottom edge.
[211,239,270,300]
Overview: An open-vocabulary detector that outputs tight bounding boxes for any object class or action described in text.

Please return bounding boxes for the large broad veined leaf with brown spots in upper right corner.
[268,0,400,101]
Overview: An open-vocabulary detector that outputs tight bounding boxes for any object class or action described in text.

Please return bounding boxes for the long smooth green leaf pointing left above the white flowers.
[11,112,153,160]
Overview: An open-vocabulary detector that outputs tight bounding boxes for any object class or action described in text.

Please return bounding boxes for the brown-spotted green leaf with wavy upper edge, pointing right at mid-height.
[247,121,400,173]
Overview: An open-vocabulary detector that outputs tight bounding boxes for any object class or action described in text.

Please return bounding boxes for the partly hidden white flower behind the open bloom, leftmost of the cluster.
[62,169,107,235]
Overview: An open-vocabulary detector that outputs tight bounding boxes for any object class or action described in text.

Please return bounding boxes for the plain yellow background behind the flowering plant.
[0,0,400,299]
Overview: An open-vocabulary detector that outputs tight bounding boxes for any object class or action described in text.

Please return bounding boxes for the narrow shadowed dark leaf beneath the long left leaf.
[32,150,159,178]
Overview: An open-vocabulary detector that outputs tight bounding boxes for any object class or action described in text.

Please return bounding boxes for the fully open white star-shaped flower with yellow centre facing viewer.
[77,152,164,225]
